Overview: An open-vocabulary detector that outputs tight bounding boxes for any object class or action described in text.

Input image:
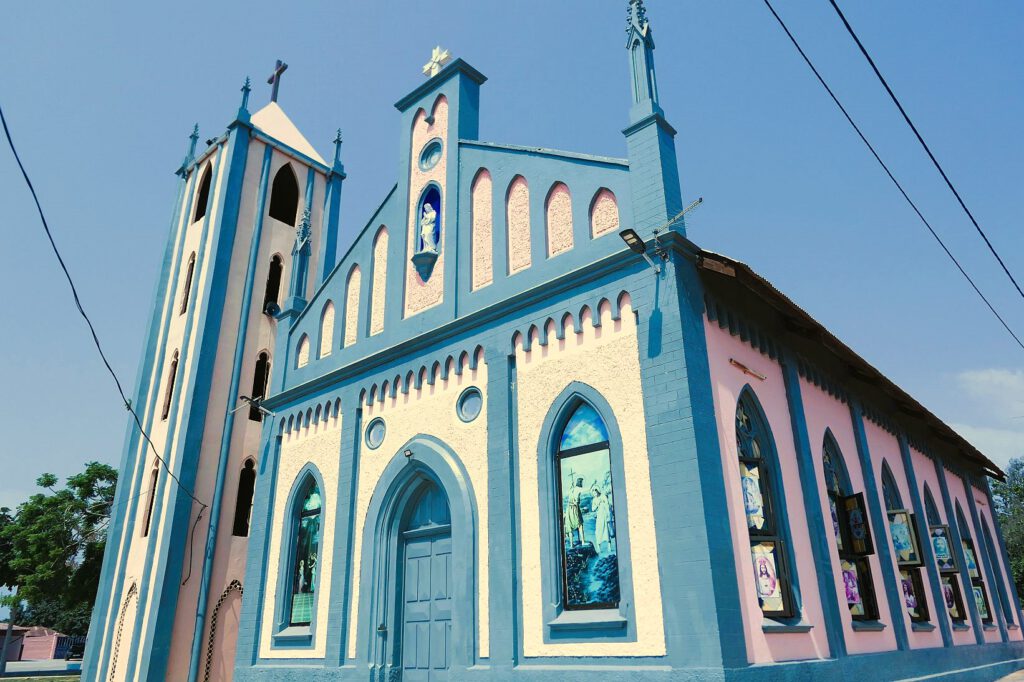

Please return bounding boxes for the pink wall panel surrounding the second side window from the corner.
[800,379,896,653]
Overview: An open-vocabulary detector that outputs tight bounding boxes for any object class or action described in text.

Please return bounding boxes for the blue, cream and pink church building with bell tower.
[83,0,1024,682]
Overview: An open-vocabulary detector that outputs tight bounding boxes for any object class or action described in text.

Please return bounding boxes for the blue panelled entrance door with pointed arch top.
[400,485,454,682]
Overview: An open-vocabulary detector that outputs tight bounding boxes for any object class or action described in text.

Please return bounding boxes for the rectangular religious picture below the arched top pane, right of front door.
[558,438,620,608]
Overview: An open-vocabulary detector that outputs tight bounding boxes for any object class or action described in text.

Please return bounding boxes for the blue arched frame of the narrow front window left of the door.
[275,464,328,634]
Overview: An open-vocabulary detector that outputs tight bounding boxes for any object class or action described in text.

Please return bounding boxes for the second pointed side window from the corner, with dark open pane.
[821,431,879,621]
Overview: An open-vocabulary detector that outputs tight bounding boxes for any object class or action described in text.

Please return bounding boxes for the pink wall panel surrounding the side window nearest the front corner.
[705,321,829,664]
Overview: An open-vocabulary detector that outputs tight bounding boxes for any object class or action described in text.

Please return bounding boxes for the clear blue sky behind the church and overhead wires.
[0,0,1024,505]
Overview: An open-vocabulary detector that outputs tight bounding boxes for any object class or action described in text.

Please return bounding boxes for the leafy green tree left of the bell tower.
[0,462,118,635]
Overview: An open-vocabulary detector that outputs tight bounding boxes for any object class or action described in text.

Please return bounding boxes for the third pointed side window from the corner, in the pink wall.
[882,460,934,623]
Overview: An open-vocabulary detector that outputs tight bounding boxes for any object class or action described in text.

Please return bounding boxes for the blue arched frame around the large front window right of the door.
[538,382,636,642]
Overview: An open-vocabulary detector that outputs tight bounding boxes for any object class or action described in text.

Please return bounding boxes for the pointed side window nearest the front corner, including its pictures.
[736,388,797,617]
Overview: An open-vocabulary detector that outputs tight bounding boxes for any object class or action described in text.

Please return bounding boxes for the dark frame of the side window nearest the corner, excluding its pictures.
[734,385,800,619]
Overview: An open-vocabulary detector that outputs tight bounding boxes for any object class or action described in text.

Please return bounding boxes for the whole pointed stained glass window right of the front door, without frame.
[555,402,620,609]
